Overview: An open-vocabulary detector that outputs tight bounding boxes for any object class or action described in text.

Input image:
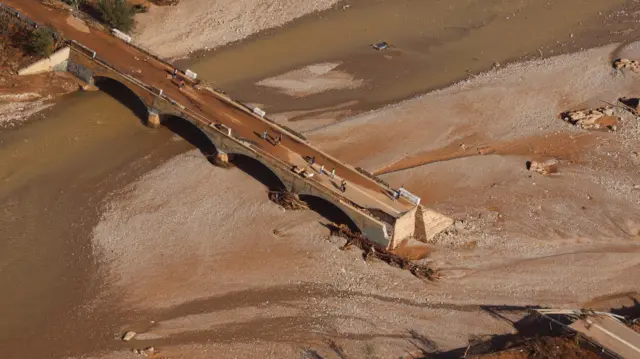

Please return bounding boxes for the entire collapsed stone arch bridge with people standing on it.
[2,0,451,248]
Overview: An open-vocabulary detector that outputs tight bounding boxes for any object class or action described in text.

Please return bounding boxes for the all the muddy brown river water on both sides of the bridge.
[0,0,637,358]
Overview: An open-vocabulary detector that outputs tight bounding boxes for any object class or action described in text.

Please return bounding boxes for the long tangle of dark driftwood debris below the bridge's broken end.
[330,224,438,280]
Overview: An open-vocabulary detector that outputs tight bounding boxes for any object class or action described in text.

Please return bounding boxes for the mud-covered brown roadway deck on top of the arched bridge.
[2,0,414,218]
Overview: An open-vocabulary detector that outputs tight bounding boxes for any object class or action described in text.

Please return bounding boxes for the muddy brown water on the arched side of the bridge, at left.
[0,88,188,358]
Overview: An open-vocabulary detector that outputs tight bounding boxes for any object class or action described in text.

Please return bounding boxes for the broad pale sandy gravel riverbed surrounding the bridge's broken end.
[85,41,640,358]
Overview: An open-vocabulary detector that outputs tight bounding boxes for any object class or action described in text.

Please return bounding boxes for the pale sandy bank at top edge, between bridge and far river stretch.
[134,0,338,58]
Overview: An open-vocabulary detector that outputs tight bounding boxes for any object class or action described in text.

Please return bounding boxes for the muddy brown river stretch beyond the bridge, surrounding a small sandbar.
[179,0,640,123]
